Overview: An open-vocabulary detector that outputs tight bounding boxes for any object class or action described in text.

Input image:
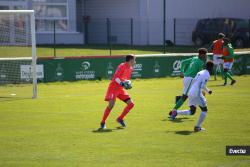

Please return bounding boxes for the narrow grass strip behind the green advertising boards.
[0,45,250,58]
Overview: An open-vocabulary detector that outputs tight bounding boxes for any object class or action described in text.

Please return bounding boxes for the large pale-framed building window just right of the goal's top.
[32,0,69,32]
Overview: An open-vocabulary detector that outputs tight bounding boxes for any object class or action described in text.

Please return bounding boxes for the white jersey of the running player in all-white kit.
[188,70,210,97]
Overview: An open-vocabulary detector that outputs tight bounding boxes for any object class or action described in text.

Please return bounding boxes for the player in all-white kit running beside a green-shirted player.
[171,61,214,132]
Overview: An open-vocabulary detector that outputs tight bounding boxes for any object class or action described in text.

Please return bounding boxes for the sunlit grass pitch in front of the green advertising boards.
[0,76,250,167]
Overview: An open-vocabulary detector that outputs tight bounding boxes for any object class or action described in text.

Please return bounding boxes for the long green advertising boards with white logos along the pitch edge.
[0,52,250,84]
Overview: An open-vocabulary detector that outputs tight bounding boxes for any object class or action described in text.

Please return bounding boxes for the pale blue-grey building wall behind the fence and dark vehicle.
[0,0,250,45]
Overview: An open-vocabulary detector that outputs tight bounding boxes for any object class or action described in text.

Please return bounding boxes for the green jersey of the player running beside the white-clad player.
[181,56,205,78]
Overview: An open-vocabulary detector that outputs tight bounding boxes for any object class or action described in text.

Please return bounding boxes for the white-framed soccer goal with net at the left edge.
[0,10,37,98]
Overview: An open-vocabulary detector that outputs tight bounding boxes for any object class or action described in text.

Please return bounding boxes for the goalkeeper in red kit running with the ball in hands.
[99,55,136,130]
